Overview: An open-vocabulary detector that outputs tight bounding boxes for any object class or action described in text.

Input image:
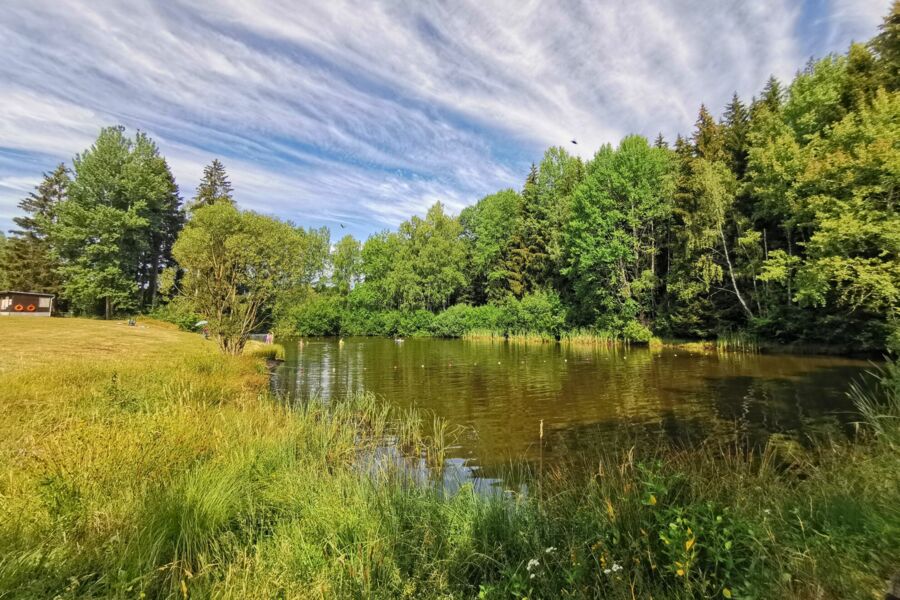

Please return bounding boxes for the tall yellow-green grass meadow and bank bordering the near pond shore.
[0,319,900,598]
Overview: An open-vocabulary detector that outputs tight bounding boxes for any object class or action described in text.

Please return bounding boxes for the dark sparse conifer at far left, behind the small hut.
[4,164,70,294]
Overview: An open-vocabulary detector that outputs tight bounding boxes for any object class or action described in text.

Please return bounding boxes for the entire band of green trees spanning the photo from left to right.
[0,3,900,350]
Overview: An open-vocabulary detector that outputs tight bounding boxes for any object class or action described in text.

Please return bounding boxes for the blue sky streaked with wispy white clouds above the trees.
[0,0,890,238]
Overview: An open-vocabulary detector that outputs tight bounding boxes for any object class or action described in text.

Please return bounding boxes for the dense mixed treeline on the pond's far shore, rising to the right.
[282,4,900,348]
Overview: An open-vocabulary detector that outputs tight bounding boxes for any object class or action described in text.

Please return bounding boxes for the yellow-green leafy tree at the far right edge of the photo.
[795,90,900,342]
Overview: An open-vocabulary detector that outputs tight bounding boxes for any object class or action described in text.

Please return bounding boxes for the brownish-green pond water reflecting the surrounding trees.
[273,338,869,476]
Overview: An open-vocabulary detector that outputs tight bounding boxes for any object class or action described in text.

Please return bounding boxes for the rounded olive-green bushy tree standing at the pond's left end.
[173,202,308,354]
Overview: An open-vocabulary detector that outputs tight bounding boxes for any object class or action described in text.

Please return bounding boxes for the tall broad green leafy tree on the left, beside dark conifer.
[50,127,182,318]
